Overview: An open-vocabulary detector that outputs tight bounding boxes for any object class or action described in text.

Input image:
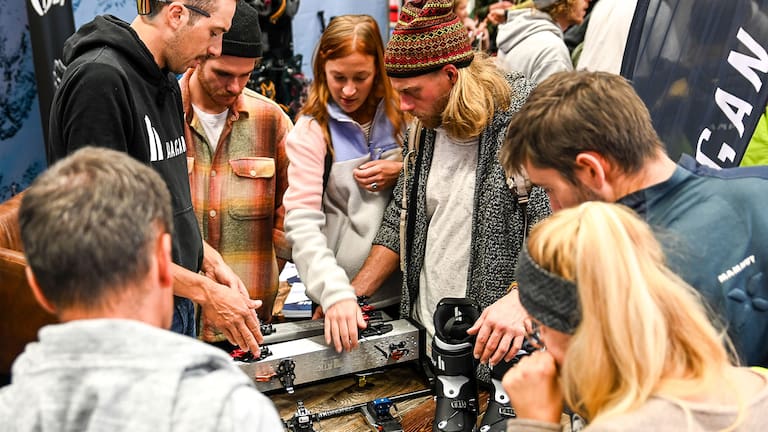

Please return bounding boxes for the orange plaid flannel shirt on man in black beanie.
[179,70,293,328]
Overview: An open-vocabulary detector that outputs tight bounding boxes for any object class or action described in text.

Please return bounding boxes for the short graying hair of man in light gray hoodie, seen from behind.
[19,147,173,308]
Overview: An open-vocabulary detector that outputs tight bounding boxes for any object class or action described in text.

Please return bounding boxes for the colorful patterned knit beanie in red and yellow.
[384,0,474,78]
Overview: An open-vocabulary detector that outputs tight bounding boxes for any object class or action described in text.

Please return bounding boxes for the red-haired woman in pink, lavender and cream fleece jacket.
[283,15,404,351]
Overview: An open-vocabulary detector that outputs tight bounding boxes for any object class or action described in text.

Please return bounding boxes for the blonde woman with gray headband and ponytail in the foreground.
[504,202,768,431]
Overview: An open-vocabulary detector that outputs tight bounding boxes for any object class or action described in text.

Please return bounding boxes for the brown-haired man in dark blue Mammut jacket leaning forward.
[500,72,768,366]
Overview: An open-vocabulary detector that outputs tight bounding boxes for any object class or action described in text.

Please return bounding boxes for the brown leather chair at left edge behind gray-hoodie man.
[0,194,56,385]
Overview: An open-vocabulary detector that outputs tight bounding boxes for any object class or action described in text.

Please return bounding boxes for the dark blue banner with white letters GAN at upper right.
[621,0,768,168]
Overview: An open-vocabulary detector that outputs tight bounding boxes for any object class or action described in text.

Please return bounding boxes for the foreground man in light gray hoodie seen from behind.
[0,147,282,432]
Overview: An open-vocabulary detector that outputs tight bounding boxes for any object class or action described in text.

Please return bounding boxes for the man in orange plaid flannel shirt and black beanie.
[179,1,292,341]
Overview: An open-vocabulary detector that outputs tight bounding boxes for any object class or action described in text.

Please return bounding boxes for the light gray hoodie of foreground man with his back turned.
[0,319,282,432]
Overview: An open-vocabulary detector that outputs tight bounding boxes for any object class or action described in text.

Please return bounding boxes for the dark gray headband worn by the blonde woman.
[515,246,581,334]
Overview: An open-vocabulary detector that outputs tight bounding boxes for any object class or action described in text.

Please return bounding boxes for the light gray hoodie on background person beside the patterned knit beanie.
[496,8,573,83]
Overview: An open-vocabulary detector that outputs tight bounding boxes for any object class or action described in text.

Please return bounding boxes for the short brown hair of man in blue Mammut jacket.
[499,71,664,183]
